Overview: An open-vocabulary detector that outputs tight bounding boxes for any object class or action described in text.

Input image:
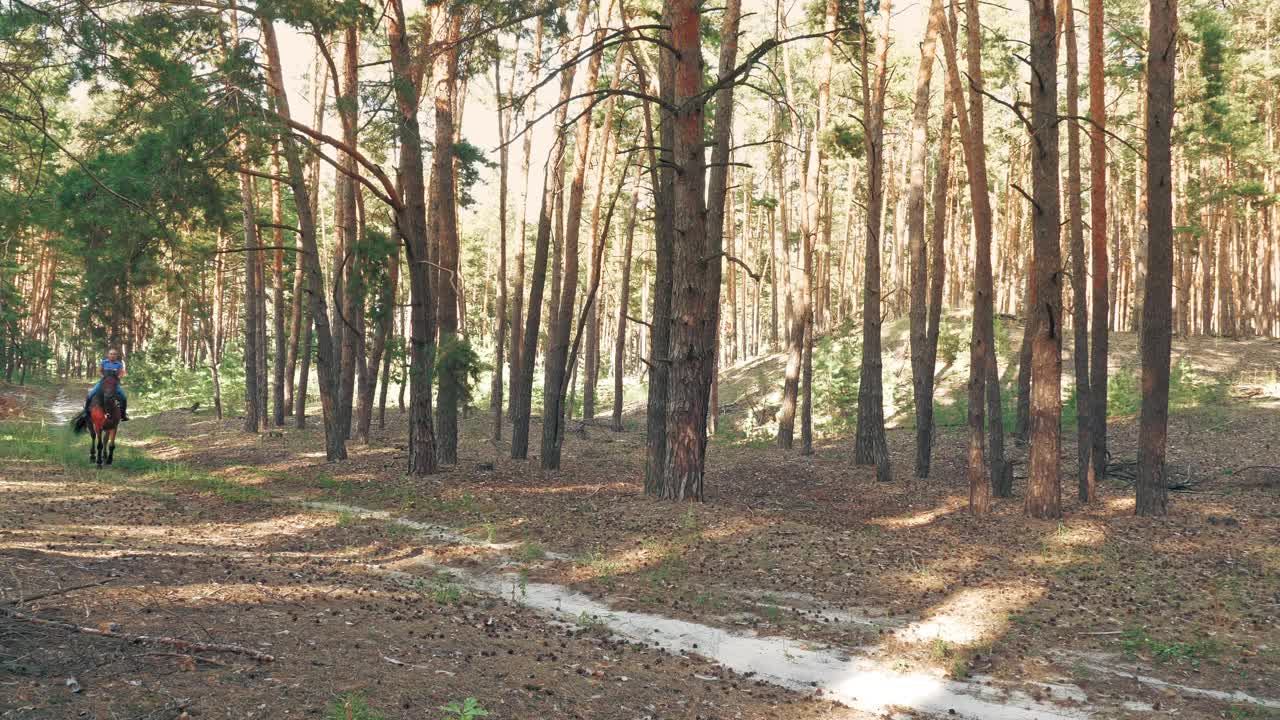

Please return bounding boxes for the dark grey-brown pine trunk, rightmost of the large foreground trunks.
[1134,0,1178,515]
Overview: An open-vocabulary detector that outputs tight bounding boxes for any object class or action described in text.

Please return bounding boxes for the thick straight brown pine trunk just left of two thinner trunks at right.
[1027,0,1062,518]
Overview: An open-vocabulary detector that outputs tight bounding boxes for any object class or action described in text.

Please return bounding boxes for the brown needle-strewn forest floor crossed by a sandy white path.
[0,327,1280,719]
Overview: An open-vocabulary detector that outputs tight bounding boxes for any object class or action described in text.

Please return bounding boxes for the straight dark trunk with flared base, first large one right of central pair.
[854,0,892,482]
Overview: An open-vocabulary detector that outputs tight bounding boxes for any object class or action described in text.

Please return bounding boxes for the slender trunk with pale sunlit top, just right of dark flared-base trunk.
[906,0,950,478]
